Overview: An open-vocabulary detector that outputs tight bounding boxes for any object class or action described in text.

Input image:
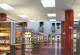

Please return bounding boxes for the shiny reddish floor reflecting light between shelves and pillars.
[16,43,66,55]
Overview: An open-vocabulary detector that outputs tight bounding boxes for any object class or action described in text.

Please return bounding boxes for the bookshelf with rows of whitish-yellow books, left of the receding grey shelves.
[25,30,34,52]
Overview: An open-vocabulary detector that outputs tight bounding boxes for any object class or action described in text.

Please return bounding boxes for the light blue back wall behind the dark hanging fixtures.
[27,21,61,35]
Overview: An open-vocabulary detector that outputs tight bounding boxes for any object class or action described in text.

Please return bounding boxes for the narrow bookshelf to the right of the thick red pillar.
[71,26,77,55]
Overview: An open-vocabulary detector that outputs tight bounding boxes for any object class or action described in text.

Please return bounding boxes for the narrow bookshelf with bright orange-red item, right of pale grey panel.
[16,23,22,50]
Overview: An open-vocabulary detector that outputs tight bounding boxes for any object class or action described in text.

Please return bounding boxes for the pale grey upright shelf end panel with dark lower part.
[10,21,16,55]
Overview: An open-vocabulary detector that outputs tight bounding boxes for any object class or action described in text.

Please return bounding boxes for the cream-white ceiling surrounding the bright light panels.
[0,0,80,22]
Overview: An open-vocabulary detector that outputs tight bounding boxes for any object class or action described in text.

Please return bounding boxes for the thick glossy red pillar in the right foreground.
[65,10,74,55]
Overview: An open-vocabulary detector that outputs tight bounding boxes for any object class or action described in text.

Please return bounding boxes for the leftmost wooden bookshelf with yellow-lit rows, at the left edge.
[0,22,10,55]
